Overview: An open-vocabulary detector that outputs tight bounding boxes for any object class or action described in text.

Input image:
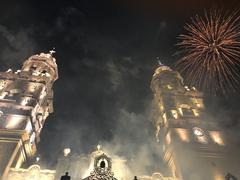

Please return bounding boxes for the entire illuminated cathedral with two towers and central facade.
[0,51,240,180]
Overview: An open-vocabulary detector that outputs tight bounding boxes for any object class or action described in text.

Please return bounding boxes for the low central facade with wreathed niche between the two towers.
[55,145,132,180]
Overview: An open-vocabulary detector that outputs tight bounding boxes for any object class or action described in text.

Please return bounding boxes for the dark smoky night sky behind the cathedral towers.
[0,0,240,169]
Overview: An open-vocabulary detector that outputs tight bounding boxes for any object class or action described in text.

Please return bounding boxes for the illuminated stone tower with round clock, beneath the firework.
[151,65,240,180]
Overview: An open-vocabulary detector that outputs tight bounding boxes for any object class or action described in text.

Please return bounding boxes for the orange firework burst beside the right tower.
[177,10,240,93]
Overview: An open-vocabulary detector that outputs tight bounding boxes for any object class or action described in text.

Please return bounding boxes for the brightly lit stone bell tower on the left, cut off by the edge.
[0,52,58,180]
